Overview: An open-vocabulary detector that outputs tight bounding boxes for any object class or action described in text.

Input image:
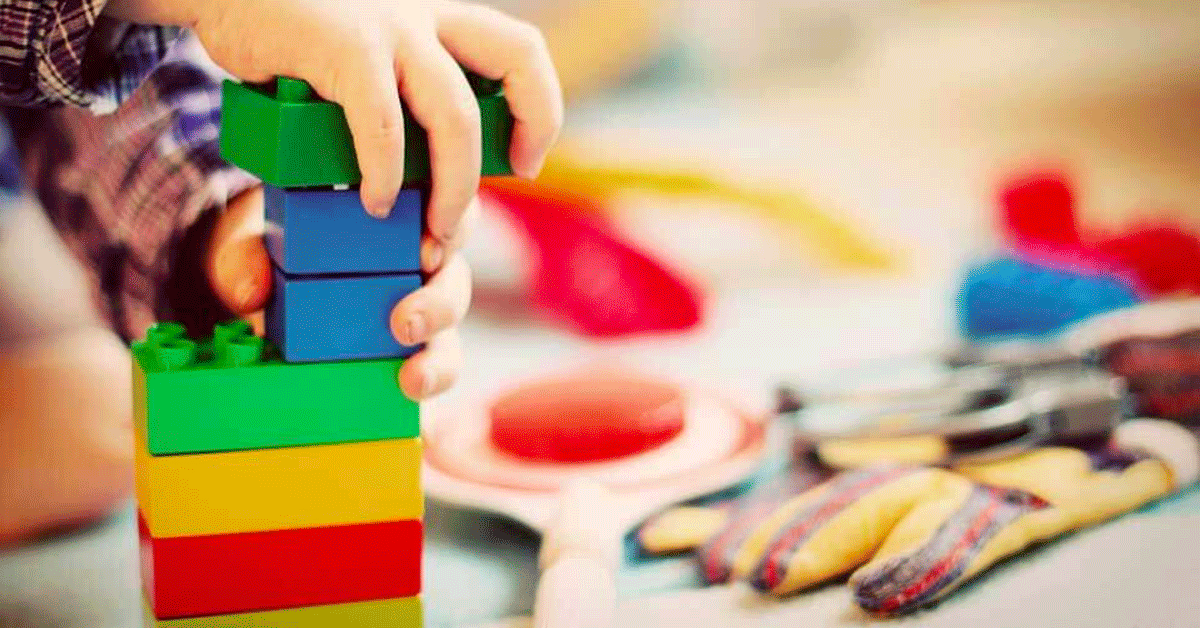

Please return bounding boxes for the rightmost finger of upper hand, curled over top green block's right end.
[438,2,563,179]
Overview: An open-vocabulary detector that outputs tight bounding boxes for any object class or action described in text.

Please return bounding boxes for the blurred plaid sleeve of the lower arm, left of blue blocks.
[14,35,256,340]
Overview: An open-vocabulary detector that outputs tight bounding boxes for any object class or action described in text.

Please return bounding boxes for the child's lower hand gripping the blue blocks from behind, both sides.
[205,187,479,400]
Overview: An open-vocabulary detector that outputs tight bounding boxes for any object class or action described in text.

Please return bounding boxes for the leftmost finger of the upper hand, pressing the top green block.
[306,40,404,217]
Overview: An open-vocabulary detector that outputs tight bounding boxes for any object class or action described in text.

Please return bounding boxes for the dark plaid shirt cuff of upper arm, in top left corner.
[0,0,179,112]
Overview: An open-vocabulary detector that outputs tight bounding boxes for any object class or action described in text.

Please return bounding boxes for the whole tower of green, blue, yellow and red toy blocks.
[132,77,512,628]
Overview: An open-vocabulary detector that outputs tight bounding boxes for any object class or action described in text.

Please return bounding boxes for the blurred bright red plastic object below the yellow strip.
[482,184,703,337]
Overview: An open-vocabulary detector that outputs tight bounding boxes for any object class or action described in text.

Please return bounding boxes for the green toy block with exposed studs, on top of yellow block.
[132,322,420,455]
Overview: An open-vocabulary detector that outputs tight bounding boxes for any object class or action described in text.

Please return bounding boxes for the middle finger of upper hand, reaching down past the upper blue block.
[397,35,482,241]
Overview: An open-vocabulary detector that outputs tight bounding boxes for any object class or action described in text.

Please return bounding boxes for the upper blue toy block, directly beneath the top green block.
[265,185,425,275]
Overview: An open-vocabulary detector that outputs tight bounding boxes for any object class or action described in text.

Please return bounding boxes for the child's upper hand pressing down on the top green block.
[104,0,563,230]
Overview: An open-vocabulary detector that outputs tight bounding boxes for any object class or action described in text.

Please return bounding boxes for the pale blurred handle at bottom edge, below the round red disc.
[533,483,622,628]
